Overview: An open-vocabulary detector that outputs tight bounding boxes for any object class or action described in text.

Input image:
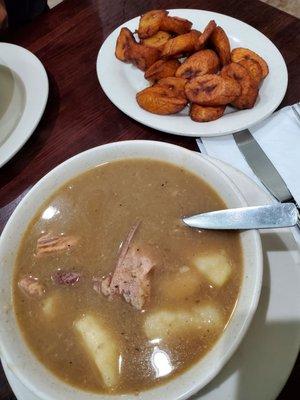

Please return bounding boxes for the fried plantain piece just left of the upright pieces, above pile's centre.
[161,29,200,58]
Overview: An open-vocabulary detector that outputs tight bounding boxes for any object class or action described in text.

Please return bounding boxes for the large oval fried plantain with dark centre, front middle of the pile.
[185,74,241,106]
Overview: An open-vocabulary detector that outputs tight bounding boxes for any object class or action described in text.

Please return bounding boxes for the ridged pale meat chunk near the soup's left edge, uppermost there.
[36,233,78,256]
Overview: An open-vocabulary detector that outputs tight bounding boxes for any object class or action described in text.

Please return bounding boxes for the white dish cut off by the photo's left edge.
[0,43,49,167]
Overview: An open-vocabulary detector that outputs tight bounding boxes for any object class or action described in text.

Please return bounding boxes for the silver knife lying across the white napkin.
[233,129,300,228]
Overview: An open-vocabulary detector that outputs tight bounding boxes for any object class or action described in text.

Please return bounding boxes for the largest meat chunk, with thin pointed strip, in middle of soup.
[100,223,154,310]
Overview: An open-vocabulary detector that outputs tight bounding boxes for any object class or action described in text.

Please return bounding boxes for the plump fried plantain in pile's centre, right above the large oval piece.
[175,50,219,79]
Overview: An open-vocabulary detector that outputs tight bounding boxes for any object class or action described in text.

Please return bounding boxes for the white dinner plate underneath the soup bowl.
[3,156,300,400]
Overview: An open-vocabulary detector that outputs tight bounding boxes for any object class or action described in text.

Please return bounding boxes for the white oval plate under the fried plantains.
[97,9,288,137]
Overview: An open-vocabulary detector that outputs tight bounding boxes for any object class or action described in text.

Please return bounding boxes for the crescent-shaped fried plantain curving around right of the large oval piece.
[221,63,258,110]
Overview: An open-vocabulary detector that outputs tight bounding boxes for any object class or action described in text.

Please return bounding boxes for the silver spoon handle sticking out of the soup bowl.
[182,203,299,230]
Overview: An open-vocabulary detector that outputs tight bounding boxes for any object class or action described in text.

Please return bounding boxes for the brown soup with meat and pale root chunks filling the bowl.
[13,159,243,393]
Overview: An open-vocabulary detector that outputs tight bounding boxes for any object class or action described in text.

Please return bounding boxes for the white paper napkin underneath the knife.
[197,106,300,204]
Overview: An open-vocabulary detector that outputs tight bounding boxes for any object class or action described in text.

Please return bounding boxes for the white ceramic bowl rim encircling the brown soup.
[0,141,262,400]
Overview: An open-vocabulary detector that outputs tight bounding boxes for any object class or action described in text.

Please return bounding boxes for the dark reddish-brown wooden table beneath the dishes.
[0,0,300,400]
